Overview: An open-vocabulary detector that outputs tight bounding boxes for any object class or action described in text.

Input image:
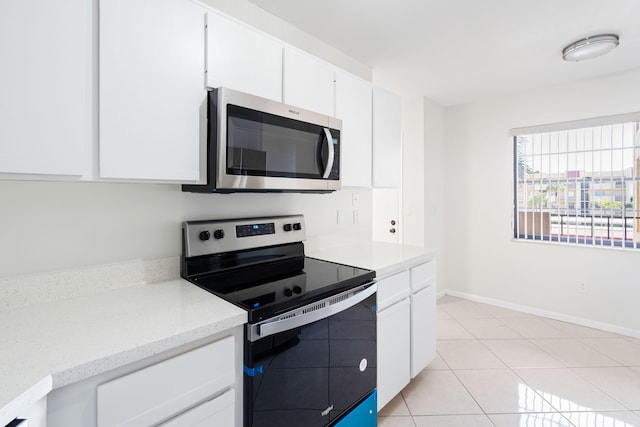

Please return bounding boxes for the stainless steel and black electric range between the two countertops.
[181,215,377,427]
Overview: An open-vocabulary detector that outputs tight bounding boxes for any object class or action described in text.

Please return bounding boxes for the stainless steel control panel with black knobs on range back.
[182,215,306,258]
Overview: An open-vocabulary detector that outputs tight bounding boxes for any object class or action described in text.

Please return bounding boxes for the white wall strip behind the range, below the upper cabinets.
[0,181,372,278]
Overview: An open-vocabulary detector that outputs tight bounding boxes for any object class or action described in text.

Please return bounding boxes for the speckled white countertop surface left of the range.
[0,279,247,425]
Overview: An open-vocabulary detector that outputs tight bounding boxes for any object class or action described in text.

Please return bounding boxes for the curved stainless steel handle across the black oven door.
[247,280,378,342]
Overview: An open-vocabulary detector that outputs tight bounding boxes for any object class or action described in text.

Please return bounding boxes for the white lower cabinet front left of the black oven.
[46,326,243,427]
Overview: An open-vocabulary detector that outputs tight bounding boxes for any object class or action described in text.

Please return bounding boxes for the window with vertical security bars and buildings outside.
[511,115,640,249]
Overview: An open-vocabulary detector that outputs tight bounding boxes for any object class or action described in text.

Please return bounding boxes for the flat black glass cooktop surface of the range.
[187,256,375,323]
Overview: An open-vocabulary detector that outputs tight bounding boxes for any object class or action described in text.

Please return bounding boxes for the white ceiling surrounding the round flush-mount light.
[249,0,640,106]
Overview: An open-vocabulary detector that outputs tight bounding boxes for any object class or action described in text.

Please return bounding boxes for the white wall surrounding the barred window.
[445,64,640,336]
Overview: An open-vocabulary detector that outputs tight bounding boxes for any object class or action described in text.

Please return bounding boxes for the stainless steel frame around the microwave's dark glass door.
[216,88,342,191]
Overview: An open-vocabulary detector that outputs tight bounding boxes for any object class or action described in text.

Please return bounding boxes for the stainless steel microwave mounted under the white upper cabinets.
[182,88,342,193]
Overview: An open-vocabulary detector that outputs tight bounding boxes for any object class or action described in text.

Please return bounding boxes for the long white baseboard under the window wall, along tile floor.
[438,289,640,338]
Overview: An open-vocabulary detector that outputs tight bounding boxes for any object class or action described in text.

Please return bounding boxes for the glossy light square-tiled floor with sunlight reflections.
[379,296,640,427]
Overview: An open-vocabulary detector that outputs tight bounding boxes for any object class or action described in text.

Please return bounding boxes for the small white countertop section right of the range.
[306,241,438,279]
